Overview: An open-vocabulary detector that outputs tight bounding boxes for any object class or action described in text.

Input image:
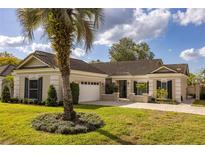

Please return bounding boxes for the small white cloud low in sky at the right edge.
[180,47,205,61]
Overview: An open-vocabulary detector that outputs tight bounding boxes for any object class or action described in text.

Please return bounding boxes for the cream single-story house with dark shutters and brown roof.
[13,51,189,102]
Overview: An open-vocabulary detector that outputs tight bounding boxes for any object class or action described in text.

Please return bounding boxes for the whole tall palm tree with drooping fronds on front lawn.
[17,8,102,120]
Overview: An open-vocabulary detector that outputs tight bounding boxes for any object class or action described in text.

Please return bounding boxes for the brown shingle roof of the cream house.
[18,51,189,75]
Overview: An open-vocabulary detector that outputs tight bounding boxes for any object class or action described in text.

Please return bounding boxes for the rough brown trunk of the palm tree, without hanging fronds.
[49,8,75,120]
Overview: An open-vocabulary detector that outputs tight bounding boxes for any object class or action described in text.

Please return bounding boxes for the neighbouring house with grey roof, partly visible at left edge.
[0,64,15,94]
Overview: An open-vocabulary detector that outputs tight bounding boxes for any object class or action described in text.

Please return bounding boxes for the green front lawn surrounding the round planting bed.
[0,103,205,144]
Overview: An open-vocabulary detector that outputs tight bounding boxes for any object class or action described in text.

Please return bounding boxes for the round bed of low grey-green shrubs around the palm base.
[32,112,104,134]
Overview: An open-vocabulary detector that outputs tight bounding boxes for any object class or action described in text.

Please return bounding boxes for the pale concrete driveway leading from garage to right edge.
[81,101,205,115]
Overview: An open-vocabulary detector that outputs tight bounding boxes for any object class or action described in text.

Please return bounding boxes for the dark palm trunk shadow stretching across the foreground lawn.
[97,129,133,145]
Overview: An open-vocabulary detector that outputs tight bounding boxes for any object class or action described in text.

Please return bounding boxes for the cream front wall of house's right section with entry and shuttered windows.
[103,74,186,102]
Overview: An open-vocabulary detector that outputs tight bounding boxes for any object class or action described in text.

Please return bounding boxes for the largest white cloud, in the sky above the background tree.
[94,9,171,45]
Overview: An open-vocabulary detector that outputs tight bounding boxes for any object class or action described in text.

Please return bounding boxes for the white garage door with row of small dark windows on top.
[79,82,100,102]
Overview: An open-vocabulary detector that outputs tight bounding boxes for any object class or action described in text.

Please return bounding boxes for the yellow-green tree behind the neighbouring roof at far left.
[0,51,21,65]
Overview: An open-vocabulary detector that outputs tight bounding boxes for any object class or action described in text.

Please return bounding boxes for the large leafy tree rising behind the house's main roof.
[109,37,154,61]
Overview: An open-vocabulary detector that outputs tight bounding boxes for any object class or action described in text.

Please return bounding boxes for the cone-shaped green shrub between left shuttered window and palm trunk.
[46,85,58,106]
